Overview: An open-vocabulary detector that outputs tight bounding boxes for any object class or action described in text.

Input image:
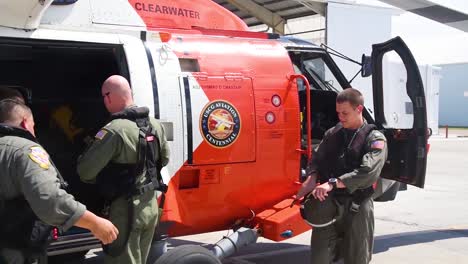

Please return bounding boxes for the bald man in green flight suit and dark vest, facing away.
[77,75,169,264]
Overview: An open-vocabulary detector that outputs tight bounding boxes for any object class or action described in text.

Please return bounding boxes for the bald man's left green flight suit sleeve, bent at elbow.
[77,128,123,183]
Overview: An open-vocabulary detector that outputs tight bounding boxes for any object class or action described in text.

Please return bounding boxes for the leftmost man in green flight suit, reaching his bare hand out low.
[0,98,119,264]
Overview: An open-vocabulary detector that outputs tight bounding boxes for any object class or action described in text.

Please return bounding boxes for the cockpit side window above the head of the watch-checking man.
[303,57,343,92]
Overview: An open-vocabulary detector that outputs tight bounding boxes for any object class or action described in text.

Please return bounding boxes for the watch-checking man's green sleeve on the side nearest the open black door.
[338,130,388,193]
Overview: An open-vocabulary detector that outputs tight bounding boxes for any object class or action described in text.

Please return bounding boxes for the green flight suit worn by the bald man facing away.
[78,105,169,264]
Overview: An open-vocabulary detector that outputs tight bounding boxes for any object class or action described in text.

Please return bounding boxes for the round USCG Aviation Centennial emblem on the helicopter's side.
[200,101,241,148]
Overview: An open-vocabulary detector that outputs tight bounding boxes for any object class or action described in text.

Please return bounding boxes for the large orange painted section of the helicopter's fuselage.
[162,33,306,240]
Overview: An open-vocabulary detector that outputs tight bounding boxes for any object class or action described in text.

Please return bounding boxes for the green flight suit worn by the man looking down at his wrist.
[310,124,387,264]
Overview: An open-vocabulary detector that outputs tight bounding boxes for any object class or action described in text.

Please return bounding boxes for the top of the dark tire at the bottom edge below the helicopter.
[154,245,221,264]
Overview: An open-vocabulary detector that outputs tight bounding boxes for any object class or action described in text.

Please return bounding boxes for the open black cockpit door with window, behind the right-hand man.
[372,37,428,188]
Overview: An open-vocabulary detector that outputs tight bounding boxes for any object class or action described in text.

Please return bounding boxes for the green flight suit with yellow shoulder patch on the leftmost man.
[0,124,86,264]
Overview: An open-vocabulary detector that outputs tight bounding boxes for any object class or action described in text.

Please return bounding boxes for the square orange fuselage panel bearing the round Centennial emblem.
[193,77,255,164]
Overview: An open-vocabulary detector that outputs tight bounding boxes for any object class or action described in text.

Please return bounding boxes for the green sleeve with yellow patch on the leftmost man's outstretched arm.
[14,146,86,230]
